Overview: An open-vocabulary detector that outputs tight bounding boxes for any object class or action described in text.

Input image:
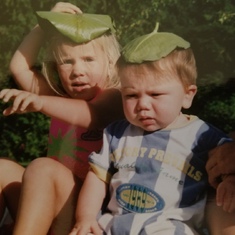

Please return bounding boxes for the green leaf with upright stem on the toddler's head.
[122,23,190,63]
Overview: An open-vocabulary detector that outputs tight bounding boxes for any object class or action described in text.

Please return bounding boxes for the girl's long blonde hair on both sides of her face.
[42,34,120,96]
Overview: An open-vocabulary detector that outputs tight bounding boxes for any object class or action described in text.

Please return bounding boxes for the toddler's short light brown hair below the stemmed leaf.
[117,48,197,88]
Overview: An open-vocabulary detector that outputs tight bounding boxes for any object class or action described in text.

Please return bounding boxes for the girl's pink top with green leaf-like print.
[47,118,103,179]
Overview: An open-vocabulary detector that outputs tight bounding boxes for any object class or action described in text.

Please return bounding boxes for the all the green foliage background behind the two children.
[0,0,235,164]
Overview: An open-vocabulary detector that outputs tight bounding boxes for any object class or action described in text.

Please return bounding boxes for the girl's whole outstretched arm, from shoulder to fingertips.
[0,89,124,128]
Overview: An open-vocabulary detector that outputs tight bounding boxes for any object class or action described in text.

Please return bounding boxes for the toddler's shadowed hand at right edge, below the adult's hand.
[216,175,235,213]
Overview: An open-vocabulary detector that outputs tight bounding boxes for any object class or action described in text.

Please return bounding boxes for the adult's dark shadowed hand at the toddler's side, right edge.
[206,141,235,188]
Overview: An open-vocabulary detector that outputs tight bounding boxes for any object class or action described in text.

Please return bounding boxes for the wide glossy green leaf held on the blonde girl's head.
[36,11,115,44]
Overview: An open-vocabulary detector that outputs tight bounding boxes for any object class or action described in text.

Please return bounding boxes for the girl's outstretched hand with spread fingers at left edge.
[0,89,43,116]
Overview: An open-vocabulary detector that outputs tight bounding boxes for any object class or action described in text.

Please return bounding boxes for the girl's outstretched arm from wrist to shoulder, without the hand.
[39,89,124,129]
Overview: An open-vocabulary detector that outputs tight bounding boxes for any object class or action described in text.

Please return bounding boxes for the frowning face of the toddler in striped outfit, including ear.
[120,72,196,131]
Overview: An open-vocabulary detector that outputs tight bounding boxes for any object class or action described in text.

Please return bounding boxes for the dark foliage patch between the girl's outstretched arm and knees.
[0,110,49,163]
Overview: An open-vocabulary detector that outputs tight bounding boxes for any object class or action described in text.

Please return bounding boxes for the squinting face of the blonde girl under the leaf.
[57,42,108,101]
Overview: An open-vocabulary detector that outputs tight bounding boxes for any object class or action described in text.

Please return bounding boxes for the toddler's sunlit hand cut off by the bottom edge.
[69,218,103,235]
